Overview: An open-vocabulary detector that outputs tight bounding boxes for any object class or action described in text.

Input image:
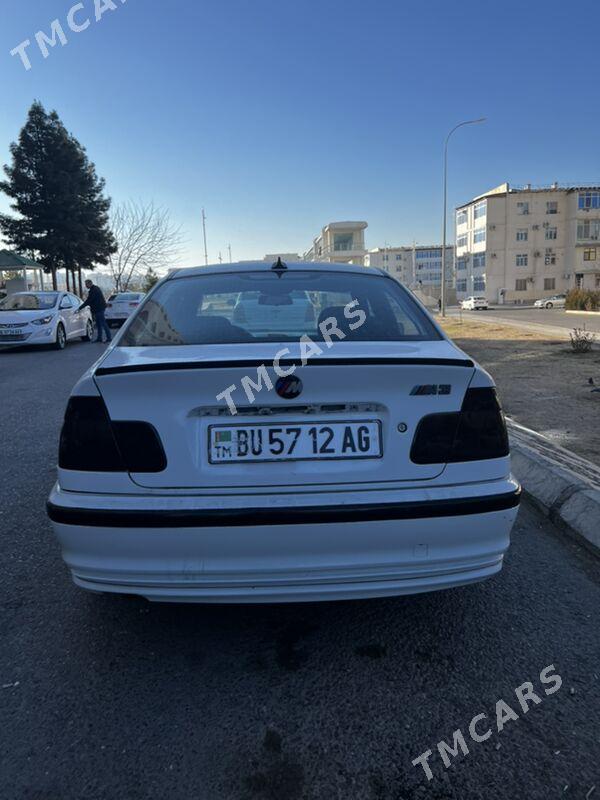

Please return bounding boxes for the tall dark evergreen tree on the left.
[0,102,116,288]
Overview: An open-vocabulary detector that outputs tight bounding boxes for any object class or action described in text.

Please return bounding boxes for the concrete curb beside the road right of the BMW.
[507,419,600,556]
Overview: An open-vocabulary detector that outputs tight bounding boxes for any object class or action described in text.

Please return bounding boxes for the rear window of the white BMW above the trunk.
[119,270,441,347]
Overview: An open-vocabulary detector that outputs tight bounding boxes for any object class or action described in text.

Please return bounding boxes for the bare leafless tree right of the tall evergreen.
[108,200,185,292]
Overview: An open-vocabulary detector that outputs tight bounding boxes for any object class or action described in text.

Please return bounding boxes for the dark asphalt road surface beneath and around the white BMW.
[0,344,600,800]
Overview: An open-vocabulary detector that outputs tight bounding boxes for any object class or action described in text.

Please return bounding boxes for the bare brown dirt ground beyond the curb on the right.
[440,319,600,464]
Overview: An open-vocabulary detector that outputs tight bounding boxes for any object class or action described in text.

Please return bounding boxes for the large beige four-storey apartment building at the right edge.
[455,183,600,303]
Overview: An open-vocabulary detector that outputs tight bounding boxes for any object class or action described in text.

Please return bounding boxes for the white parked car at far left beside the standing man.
[0,292,93,350]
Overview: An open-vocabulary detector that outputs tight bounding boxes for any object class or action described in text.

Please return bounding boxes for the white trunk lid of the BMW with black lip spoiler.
[95,340,474,490]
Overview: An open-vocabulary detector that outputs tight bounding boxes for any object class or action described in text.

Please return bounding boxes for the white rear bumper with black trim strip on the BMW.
[48,478,520,603]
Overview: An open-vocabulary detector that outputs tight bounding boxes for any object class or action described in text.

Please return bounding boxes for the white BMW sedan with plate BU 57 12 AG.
[48,262,520,603]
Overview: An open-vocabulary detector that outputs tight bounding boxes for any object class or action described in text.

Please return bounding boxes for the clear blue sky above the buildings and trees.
[0,0,600,264]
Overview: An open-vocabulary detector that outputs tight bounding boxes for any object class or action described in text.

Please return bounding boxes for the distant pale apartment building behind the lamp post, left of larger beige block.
[365,244,454,296]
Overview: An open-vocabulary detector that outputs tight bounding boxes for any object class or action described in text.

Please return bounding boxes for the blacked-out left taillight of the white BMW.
[58,397,167,472]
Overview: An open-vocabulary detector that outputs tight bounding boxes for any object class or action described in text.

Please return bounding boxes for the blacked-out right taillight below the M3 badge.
[410,387,509,464]
